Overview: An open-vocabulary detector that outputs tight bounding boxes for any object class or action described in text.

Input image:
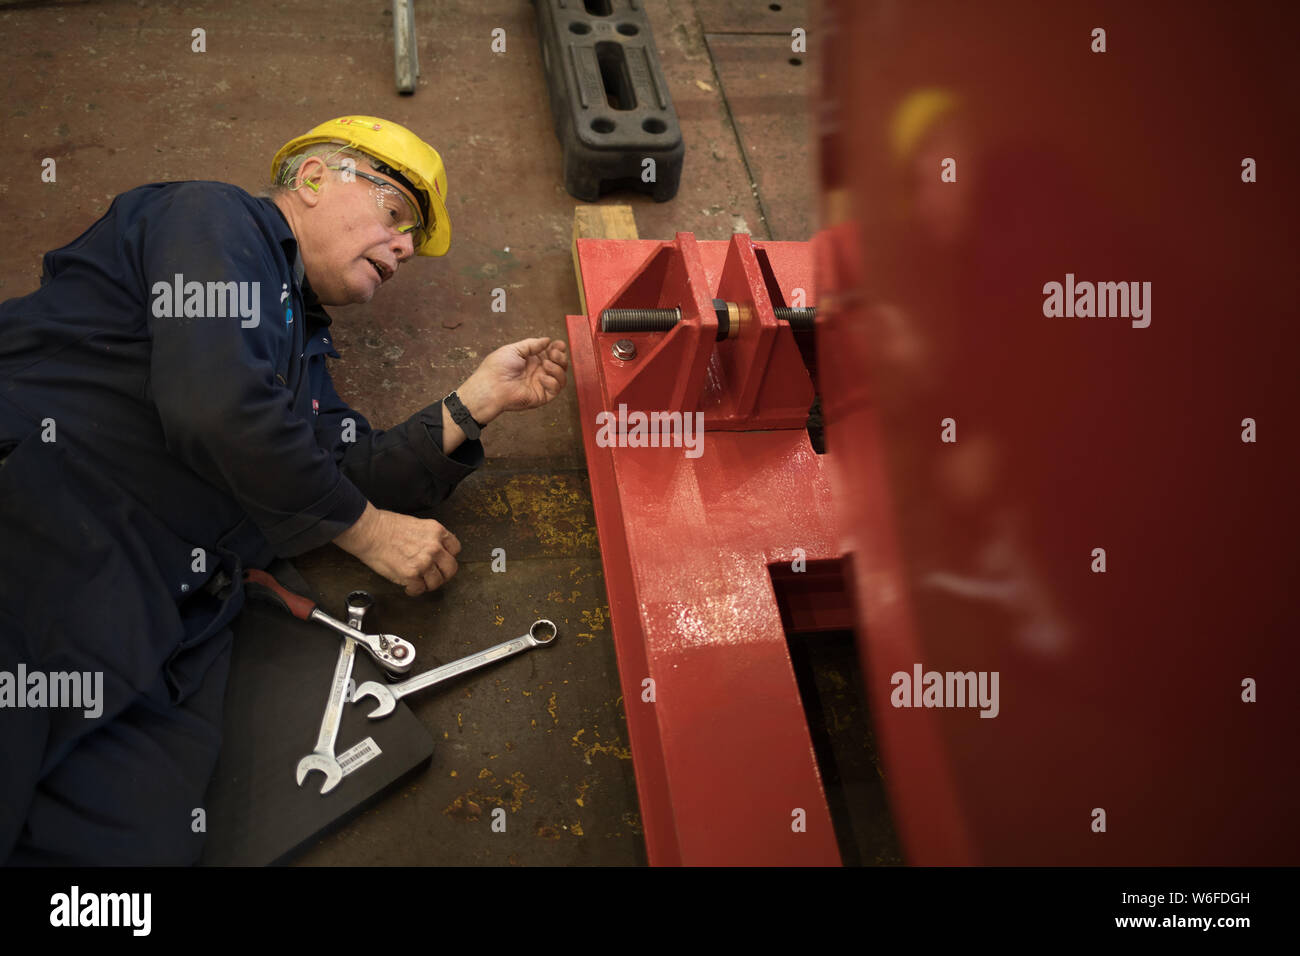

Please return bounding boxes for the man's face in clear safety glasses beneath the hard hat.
[295,157,416,306]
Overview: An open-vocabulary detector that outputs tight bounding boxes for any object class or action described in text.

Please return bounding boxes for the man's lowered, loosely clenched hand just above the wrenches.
[334,502,460,597]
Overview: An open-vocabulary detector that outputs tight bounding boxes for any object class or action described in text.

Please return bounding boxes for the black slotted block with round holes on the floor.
[533,0,686,203]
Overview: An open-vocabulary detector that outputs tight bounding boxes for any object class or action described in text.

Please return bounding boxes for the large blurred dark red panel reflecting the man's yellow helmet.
[810,0,1300,865]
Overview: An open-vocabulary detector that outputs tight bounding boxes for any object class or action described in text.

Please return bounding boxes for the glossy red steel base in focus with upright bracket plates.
[567,233,840,865]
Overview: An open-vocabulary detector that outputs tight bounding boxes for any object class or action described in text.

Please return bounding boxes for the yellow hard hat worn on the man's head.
[270,116,451,256]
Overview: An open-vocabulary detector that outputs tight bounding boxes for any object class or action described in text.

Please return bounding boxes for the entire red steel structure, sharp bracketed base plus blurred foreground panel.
[568,0,1300,865]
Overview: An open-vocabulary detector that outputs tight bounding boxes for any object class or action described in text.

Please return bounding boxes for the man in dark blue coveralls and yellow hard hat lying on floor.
[0,116,568,864]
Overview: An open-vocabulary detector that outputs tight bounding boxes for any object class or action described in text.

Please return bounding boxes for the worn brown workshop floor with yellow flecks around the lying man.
[0,0,892,865]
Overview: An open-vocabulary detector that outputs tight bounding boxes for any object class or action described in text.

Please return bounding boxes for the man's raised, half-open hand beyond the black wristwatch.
[456,338,568,425]
